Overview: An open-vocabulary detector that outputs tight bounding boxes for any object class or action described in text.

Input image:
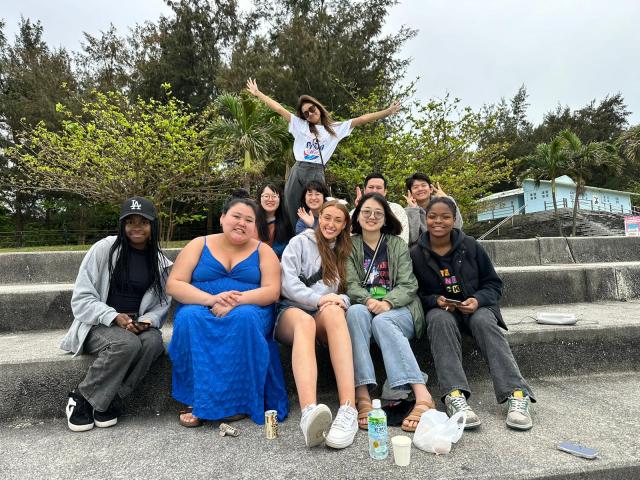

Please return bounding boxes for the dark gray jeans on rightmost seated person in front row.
[426,307,535,403]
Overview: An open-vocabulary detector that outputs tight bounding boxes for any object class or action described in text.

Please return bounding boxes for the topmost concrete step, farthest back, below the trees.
[0,237,640,285]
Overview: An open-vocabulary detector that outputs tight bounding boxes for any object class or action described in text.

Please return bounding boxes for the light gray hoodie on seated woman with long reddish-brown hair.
[281,228,350,310]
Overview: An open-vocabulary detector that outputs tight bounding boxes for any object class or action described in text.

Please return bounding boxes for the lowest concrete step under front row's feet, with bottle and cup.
[0,371,640,480]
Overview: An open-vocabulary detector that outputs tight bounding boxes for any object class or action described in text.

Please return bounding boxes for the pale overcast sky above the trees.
[0,0,640,124]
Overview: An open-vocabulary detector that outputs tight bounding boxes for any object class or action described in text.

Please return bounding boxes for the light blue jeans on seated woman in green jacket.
[347,304,424,388]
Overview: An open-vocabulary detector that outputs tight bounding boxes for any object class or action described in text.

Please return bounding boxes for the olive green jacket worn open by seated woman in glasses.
[347,235,425,338]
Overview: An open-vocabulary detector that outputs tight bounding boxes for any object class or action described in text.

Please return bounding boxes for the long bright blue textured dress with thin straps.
[169,240,289,424]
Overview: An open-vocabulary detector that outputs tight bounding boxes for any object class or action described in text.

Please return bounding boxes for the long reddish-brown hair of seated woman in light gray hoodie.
[315,200,351,293]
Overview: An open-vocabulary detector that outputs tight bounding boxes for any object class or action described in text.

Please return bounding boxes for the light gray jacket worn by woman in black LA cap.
[60,235,172,355]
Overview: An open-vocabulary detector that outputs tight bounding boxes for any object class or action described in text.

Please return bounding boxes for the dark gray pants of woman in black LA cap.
[78,323,164,412]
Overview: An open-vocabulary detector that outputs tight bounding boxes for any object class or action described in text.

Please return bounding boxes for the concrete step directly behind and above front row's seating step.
[0,256,640,332]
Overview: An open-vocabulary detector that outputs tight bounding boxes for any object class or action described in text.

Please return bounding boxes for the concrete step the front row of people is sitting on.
[0,301,640,419]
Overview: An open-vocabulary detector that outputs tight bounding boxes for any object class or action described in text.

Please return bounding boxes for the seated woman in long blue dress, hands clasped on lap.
[167,198,288,427]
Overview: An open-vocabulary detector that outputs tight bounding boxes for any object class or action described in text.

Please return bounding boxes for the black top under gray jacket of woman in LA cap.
[107,248,151,314]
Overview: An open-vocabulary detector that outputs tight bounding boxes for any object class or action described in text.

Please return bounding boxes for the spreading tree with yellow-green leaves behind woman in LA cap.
[10,86,227,240]
